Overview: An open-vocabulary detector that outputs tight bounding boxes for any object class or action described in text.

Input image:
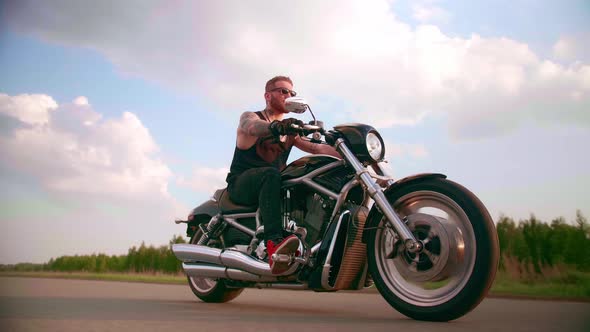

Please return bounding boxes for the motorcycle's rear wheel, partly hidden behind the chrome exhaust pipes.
[187,222,244,303]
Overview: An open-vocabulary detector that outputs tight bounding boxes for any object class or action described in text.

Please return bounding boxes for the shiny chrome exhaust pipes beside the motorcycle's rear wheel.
[172,244,299,281]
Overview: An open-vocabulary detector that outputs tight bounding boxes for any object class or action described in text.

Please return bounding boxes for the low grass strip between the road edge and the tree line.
[0,271,590,302]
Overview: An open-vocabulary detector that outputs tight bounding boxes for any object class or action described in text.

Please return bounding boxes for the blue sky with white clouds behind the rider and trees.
[0,0,590,264]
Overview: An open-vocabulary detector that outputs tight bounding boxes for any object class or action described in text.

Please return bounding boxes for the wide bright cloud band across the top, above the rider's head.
[6,0,590,139]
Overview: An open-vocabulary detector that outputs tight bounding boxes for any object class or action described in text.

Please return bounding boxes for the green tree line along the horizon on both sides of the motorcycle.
[0,210,590,279]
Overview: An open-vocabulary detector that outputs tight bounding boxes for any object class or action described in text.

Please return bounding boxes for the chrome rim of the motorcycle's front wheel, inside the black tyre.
[374,191,476,306]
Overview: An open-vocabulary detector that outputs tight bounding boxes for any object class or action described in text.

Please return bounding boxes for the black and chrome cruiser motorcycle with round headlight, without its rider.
[172,97,499,321]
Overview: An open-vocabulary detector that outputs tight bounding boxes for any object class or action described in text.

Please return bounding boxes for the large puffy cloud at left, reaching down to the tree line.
[0,94,186,262]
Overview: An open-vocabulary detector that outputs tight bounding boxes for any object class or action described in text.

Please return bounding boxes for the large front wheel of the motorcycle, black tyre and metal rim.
[367,178,499,321]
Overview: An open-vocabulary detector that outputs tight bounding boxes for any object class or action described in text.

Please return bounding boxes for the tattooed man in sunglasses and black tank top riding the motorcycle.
[226,76,341,274]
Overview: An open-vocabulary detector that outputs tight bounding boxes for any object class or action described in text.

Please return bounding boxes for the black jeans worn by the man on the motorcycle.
[227,167,283,241]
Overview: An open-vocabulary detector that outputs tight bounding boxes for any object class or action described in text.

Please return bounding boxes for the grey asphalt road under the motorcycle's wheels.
[0,277,590,332]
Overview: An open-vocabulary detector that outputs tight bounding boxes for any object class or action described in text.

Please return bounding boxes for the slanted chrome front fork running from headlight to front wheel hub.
[336,138,419,245]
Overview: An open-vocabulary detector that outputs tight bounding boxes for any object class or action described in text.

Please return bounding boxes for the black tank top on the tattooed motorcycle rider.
[226,112,295,183]
